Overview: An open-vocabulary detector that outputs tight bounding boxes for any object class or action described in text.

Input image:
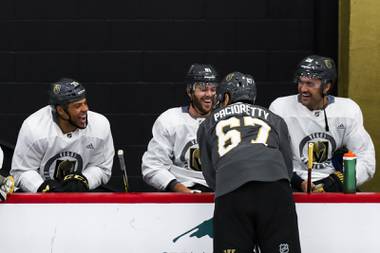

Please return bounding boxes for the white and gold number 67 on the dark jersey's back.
[215,116,271,156]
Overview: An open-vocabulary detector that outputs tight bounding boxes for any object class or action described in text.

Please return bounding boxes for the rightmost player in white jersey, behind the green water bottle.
[269,55,375,192]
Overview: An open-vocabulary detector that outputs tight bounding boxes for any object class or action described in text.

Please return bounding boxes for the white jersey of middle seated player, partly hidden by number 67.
[141,107,207,190]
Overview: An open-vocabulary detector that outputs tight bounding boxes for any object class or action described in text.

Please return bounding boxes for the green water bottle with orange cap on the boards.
[343,151,356,193]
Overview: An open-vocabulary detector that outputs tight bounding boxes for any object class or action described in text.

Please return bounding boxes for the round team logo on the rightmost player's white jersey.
[299,133,336,169]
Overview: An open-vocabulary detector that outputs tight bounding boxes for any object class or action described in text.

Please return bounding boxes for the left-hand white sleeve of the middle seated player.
[141,114,176,190]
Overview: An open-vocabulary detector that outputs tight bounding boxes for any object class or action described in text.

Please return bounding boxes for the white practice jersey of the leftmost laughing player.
[10,106,114,192]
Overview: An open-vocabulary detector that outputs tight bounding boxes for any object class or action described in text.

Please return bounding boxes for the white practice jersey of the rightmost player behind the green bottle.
[269,95,375,185]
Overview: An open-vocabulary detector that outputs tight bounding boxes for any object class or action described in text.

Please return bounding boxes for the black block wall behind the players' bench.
[0,0,338,191]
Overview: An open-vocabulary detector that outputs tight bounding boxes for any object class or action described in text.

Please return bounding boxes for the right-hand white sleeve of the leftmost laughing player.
[82,119,115,190]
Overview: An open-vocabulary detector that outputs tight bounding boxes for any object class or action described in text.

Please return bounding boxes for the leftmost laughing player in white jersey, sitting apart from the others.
[10,78,114,192]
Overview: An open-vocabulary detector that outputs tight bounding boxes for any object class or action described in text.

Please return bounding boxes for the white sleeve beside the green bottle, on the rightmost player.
[344,103,376,186]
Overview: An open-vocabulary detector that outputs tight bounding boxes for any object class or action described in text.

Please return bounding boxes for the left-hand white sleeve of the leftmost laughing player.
[10,122,44,192]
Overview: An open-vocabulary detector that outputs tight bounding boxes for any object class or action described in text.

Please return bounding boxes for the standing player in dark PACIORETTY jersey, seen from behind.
[198,72,300,253]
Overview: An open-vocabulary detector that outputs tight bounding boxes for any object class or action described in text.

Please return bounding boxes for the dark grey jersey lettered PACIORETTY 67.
[197,102,293,197]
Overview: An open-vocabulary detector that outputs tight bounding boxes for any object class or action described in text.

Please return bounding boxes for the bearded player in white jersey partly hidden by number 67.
[141,64,217,193]
